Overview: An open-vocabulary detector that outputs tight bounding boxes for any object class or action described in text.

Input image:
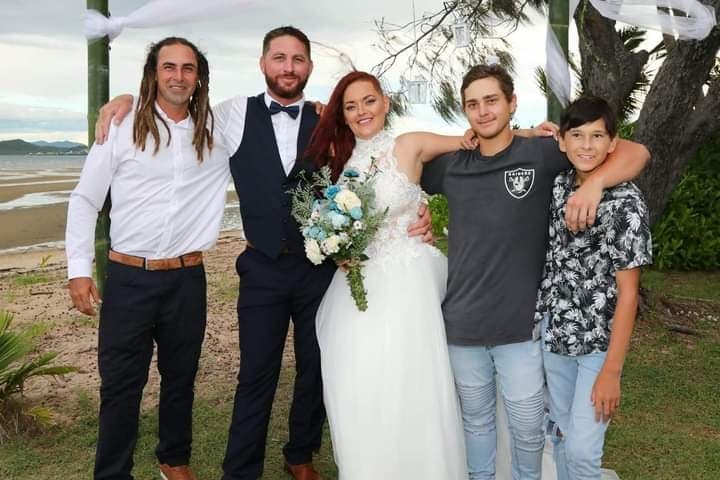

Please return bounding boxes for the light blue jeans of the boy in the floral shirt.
[543,352,608,480]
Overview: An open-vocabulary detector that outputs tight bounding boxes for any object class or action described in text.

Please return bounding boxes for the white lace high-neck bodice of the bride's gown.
[346,131,439,264]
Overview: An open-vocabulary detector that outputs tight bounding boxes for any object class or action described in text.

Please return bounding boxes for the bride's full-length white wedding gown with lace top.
[317,132,468,480]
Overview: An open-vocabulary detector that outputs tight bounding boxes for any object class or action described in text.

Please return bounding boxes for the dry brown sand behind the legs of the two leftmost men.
[0,234,282,423]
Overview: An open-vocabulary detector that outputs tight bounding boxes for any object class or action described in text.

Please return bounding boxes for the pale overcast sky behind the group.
[0,0,556,143]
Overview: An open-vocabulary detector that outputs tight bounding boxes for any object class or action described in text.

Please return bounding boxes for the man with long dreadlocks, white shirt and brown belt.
[66,37,230,480]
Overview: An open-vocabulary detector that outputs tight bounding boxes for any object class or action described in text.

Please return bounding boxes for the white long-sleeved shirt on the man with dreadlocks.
[65,105,230,278]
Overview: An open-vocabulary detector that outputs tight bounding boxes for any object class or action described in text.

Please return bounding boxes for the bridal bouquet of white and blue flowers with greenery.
[291,161,387,312]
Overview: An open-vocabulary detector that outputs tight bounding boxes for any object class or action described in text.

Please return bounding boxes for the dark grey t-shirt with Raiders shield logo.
[422,137,570,346]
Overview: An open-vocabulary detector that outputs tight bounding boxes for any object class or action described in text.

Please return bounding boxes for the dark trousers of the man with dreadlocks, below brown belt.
[94,262,207,480]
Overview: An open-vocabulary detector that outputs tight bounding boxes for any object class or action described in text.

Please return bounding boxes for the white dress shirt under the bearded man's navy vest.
[213,92,305,175]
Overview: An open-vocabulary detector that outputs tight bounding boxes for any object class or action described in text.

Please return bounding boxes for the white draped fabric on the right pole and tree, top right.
[545,0,717,106]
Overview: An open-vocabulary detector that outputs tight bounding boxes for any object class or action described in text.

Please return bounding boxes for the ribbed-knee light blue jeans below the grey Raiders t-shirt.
[449,341,545,480]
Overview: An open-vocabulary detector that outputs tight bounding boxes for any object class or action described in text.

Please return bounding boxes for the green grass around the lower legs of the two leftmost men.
[0,369,337,480]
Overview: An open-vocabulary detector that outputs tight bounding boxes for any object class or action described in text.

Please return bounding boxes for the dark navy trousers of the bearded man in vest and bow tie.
[223,248,335,480]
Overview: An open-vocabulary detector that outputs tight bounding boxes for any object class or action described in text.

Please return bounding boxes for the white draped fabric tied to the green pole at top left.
[84,0,252,41]
